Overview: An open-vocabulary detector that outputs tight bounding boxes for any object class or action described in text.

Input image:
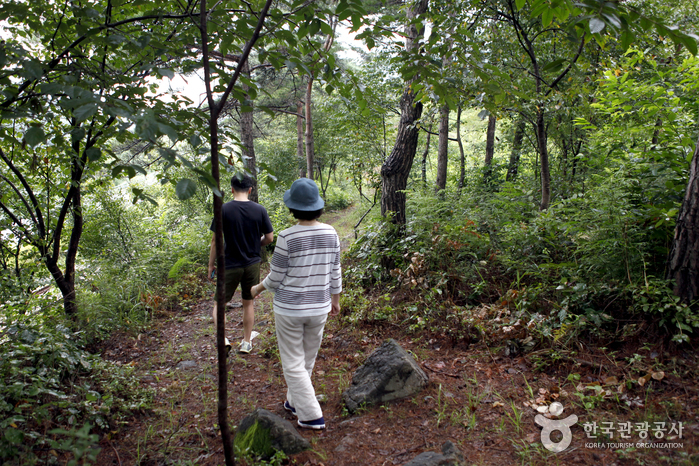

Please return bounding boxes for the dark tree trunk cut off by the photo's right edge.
[667,136,699,304]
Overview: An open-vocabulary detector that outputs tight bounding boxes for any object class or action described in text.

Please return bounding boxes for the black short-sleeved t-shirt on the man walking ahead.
[210,200,273,269]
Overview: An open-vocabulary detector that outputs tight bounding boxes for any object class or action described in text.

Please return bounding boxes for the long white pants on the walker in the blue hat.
[274,314,328,421]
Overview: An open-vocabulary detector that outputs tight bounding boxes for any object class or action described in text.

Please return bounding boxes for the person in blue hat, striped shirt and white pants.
[251,178,342,429]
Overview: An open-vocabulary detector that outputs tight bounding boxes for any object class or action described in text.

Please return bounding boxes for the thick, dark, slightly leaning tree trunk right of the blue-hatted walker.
[381,0,428,225]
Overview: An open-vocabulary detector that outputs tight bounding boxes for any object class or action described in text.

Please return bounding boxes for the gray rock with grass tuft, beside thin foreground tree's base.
[233,408,311,459]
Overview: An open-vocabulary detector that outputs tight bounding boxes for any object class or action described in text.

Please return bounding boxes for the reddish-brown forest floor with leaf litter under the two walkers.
[97,208,699,466]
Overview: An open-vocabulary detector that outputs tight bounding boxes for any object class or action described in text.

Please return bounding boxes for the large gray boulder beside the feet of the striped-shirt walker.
[342,339,427,412]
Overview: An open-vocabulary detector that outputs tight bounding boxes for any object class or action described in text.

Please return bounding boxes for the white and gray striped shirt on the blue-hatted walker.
[262,223,342,317]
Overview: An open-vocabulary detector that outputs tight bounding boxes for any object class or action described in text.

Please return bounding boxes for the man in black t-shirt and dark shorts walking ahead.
[209,175,274,353]
